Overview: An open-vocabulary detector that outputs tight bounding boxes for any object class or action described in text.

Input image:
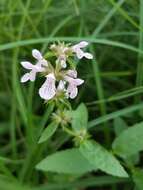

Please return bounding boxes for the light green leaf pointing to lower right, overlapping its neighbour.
[80,141,128,177]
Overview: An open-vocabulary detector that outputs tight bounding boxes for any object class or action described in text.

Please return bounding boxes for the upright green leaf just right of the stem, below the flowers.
[71,103,88,132]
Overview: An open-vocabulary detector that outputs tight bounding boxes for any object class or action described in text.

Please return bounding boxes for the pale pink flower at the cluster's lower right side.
[64,70,84,99]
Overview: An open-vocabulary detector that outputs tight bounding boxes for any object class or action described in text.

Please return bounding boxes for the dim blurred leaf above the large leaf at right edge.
[113,117,128,136]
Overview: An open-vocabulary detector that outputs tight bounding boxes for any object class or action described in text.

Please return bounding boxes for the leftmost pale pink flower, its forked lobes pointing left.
[21,61,45,82]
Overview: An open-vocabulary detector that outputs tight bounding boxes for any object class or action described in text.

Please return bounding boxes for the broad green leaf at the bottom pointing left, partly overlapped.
[36,148,96,174]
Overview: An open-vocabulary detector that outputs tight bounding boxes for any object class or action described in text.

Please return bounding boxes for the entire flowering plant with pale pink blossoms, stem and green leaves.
[21,41,128,177]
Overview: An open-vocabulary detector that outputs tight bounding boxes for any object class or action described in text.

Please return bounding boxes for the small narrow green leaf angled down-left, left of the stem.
[38,122,58,143]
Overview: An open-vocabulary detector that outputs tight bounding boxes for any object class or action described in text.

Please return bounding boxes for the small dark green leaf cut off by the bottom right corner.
[132,168,143,190]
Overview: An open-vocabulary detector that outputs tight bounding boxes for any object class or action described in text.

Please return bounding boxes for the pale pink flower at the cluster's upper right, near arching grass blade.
[72,41,93,59]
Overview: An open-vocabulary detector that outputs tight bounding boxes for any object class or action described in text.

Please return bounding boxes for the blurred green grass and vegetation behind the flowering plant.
[0,0,143,190]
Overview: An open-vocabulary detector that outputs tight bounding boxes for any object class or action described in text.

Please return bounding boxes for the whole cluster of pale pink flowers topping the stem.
[21,41,93,101]
